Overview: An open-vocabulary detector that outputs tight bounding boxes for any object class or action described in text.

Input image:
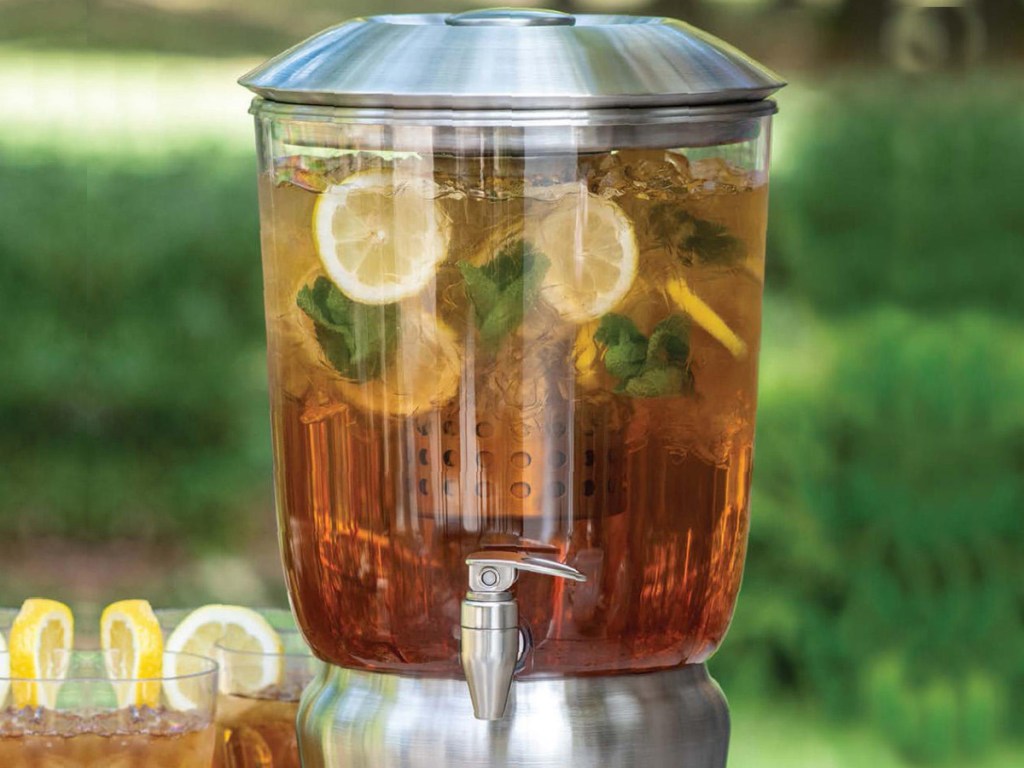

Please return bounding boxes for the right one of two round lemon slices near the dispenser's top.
[526,188,638,324]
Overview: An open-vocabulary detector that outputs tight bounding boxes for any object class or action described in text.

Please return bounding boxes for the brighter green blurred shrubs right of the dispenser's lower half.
[715,307,1024,760]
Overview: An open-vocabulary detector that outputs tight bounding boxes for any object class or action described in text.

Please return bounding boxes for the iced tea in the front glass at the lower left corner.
[0,711,214,768]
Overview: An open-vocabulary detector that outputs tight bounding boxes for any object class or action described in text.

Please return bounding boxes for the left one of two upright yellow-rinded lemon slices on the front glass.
[9,598,75,709]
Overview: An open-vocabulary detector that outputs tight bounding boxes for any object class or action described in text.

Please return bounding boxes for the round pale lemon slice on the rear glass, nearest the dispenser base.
[164,605,284,710]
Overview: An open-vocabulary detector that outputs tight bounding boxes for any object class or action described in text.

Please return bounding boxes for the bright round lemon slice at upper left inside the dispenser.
[313,171,451,304]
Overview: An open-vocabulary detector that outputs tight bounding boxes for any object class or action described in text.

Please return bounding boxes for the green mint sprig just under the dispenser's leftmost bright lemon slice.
[295,278,398,381]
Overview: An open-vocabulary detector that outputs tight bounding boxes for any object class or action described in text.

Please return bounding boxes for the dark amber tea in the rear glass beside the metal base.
[214,695,300,768]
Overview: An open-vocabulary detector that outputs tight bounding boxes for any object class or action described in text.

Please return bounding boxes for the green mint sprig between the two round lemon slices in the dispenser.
[459,240,549,349]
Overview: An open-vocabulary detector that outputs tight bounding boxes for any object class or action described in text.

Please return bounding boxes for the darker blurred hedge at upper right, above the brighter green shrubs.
[769,73,1024,317]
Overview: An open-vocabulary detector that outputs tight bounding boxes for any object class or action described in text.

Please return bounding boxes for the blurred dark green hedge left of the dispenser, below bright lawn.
[0,146,269,541]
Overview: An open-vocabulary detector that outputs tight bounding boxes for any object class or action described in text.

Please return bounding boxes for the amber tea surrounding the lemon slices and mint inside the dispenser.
[260,147,767,676]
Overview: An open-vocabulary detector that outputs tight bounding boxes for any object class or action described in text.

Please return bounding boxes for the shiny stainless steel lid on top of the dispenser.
[239,8,784,110]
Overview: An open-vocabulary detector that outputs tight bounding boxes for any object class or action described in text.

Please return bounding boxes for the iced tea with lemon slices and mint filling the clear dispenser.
[260,138,767,676]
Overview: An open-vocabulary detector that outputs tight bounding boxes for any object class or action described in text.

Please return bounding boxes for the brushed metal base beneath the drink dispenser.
[298,665,729,768]
